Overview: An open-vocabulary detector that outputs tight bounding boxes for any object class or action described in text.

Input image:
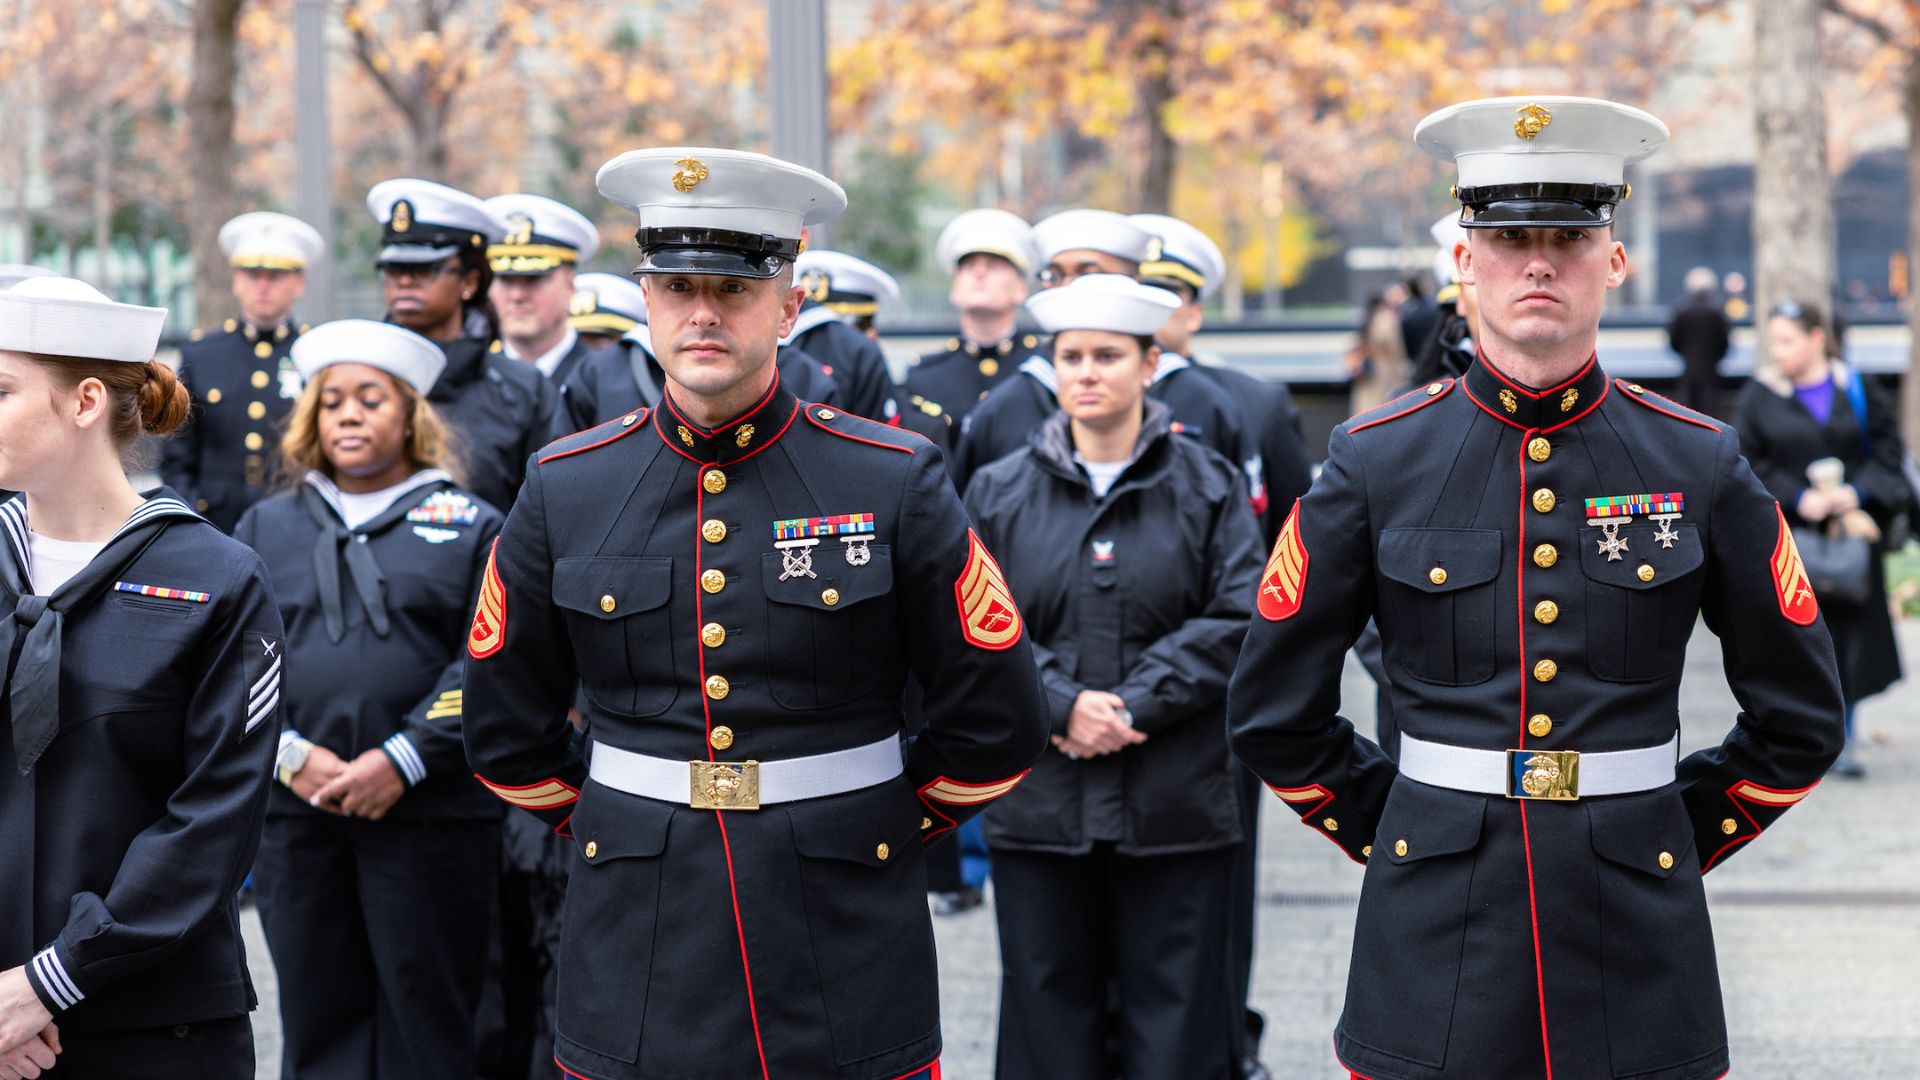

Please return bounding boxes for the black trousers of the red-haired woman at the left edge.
[40,1017,253,1080]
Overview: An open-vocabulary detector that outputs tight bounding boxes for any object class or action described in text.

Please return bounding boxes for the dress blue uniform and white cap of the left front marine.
[465,148,1044,1080]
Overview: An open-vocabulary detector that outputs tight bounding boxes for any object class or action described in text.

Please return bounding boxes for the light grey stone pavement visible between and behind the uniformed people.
[248,621,1920,1080]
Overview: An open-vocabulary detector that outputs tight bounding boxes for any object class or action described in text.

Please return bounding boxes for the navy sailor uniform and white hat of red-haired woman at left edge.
[0,277,282,1080]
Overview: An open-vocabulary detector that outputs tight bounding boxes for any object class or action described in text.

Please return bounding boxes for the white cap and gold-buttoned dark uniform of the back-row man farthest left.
[159,213,324,530]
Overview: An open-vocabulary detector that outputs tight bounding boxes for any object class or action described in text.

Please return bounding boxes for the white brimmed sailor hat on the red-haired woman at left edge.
[0,275,167,363]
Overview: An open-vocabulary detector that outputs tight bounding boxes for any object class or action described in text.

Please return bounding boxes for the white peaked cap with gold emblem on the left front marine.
[595,146,847,279]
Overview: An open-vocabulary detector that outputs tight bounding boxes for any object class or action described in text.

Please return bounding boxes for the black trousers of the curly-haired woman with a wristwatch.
[253,813,499,1080]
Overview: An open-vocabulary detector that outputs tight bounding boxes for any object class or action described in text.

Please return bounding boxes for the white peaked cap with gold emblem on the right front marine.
[1413,98,1667,229]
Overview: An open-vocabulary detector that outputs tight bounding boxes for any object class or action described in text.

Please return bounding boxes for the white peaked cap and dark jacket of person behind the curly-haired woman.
[367,179,557,507]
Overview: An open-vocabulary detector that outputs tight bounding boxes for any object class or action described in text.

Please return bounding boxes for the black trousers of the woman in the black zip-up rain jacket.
[993,842,1242,1080]
